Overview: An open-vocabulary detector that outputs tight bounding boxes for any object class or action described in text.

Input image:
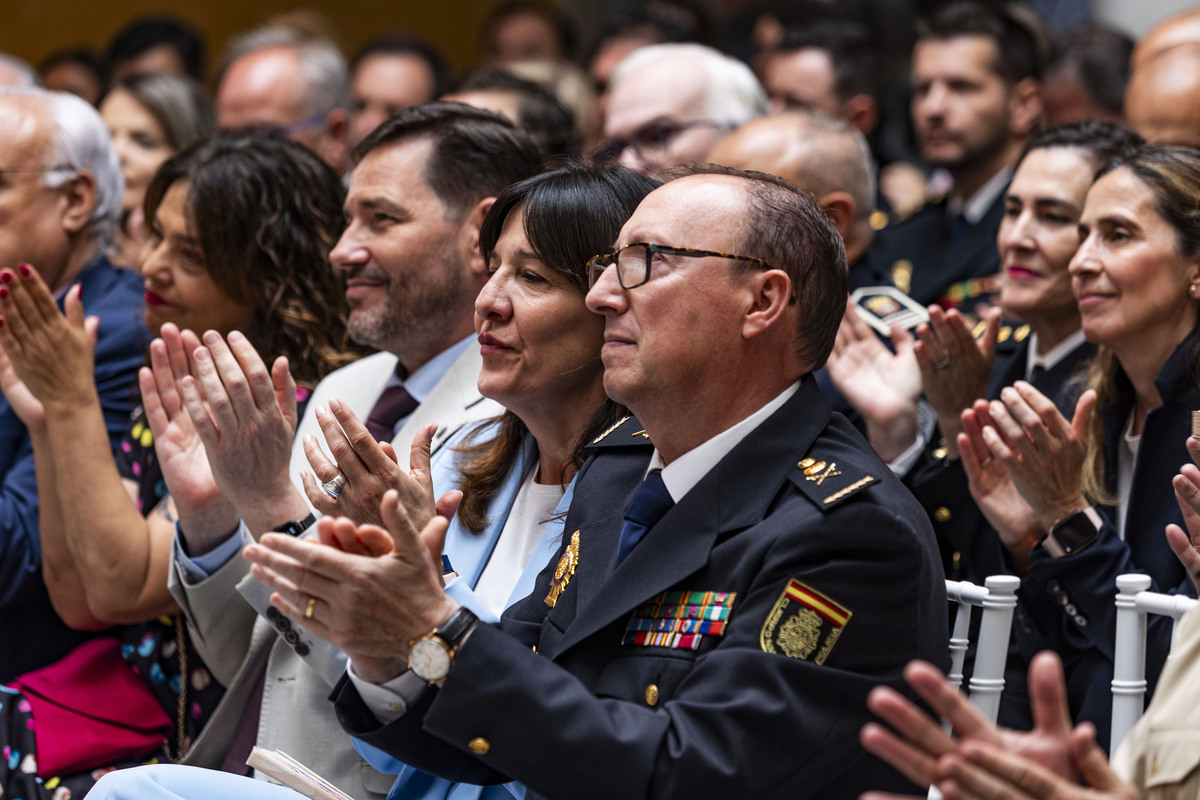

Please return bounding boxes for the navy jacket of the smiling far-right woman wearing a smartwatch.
[1014,335,1200,744]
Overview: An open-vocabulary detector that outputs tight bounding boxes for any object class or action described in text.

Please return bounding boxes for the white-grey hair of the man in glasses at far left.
[0,86,125,245]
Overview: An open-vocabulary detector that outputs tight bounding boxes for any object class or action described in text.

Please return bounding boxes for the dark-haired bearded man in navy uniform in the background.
[871,2,1044,311]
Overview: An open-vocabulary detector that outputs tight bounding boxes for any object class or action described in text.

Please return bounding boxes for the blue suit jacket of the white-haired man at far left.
[0,258,150,681]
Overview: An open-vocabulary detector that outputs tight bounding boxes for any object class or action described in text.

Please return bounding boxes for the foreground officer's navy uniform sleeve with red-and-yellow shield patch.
[338,494,946,800]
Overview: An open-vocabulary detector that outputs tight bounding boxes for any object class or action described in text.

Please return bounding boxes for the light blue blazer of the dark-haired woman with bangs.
[354,423,575,800]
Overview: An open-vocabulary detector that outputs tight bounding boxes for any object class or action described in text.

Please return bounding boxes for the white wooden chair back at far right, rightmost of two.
[1109,572,1198,753]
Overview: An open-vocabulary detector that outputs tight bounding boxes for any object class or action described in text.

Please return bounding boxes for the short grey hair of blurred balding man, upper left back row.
[217,25,350,114]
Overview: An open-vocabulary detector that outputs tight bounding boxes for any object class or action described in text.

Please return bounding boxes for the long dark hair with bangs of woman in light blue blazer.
[458,162,659,534]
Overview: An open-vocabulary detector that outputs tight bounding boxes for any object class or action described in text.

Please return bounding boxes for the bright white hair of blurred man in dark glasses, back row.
[611,43,767,127]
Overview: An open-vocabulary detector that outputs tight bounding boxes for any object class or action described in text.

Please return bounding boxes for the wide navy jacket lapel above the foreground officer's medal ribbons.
[558,383,830,654]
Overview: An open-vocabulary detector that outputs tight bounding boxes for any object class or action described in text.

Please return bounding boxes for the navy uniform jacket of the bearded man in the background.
[869,192,1004,311]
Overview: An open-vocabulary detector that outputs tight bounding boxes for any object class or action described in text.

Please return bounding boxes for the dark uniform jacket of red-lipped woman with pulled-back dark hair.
[906,325,1094,585]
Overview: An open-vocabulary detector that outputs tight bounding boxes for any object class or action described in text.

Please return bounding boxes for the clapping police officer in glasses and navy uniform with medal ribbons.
[236,167,948,798]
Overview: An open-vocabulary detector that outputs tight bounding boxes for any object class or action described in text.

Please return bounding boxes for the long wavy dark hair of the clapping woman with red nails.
[145,134,358,387]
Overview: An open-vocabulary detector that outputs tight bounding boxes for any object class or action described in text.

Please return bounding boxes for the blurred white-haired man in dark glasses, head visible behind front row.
[596,44,767,174]
